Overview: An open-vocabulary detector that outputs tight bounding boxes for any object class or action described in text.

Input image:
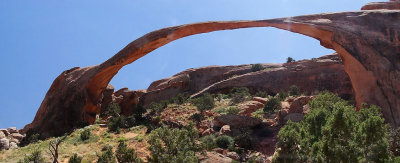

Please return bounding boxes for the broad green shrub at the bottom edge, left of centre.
[147,124,199,163]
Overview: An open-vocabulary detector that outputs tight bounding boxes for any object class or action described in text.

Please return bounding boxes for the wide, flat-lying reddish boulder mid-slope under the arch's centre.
[213,114,262,128]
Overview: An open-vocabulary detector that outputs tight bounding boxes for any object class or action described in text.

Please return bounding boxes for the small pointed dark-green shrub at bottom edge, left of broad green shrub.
[115,141,143,163]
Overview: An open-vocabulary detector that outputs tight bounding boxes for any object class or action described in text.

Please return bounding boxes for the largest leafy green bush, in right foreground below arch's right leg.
[274,92,390,162]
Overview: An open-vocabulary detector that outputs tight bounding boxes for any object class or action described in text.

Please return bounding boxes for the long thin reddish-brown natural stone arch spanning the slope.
[24,10,400,137]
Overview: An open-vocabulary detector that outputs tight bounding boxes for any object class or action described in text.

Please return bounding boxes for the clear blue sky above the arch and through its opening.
[0,0,378,128]
